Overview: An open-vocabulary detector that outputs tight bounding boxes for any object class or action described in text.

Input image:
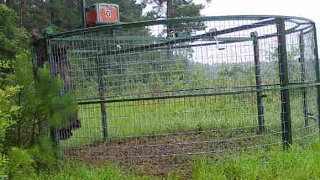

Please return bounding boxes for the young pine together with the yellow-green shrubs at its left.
[0,54,77,179]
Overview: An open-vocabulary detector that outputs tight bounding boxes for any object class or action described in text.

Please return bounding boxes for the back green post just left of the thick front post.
[251,32,264,134]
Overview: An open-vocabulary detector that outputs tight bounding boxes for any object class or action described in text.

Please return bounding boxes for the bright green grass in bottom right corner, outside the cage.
[193,142,320,180]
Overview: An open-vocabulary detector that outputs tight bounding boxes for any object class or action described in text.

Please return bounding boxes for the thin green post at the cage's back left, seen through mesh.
[96,58,108,142]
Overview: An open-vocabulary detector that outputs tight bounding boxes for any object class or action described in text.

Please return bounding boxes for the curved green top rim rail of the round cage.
[48,15,315,38]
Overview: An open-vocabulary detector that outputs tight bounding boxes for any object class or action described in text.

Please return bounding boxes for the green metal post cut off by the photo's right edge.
[313,23,320,132]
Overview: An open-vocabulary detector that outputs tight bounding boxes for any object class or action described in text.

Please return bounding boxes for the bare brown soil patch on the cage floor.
[64,131,261,179]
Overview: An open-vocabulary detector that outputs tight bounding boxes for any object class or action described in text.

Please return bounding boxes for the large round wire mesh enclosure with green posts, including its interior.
[40,16,319,172]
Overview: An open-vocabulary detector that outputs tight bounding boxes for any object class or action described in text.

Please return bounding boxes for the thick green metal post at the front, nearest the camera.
[276,18,292,149]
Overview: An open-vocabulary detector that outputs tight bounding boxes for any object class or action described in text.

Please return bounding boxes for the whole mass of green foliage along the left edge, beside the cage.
[0,5,77,176]
